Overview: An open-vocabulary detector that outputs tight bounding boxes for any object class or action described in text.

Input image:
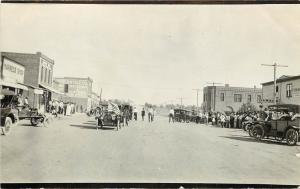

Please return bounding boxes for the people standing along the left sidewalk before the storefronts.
[47,100,75,116]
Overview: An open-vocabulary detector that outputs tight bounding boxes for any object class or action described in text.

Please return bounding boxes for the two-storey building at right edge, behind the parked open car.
[262,75,300,105]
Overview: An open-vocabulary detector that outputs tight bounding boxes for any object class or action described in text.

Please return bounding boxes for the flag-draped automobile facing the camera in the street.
[95,103,121,130]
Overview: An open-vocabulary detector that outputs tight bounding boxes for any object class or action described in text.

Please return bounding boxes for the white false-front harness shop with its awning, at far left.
[0,56,28,94]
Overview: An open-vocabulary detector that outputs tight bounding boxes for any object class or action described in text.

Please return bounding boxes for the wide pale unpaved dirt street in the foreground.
[0,114,300,185]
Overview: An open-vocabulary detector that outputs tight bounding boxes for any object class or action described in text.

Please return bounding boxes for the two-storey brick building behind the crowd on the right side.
[202,84,262,112]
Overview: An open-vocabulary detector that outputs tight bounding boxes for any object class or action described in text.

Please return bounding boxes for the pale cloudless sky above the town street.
[0,4,300,105]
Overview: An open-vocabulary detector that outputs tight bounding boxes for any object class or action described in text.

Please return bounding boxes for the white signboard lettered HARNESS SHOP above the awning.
[1,58,25,83]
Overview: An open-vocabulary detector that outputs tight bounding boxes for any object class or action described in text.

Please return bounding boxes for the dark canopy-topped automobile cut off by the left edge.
[0,90,18,135]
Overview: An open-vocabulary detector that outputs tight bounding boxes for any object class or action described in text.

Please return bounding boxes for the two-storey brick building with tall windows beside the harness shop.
[2,52,57,111]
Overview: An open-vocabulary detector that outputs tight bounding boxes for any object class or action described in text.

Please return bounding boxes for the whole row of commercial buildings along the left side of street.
[0,52,99,112]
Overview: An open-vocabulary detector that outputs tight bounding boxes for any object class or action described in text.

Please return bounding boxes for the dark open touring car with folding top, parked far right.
[251,104,300,145]
